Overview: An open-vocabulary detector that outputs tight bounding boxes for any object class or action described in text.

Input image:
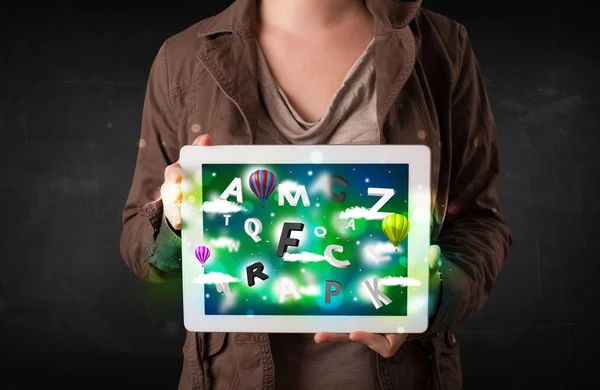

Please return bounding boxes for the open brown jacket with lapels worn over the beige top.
[121,0,512,390]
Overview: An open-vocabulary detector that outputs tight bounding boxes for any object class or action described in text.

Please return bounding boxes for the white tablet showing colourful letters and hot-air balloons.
[180,145,431,333]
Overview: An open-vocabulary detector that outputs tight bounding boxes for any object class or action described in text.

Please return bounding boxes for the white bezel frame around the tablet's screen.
[180,145,431,333]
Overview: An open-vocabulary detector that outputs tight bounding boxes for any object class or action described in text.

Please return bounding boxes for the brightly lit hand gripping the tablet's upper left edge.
[160,134,211,230]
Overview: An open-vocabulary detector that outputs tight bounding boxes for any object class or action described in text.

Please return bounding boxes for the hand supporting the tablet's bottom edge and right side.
[315,245,440,358]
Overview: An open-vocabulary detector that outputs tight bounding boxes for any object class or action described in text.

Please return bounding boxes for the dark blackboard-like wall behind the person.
[0,0,600,390]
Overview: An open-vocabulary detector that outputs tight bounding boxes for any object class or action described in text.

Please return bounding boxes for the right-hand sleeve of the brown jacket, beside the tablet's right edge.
[426,26,512,333]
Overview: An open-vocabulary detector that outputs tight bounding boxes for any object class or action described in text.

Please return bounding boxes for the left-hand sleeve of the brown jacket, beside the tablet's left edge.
[120,42,181,282]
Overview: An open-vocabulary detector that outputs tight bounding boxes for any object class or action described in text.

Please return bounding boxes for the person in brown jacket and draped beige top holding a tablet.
[121,0,512,390]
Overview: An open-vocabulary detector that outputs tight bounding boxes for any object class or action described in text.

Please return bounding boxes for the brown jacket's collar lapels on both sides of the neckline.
[196,0,421,143]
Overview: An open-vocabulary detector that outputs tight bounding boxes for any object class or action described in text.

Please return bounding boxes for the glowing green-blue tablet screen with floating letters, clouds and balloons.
[184,163,418,316]
